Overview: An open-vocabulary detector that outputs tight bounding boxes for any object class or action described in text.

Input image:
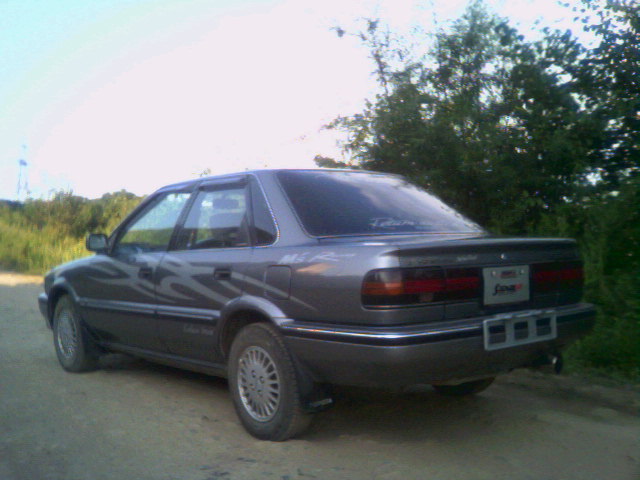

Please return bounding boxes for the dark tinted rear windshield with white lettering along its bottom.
[277,170,482,237]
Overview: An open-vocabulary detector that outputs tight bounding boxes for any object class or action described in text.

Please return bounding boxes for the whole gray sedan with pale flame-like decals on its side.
[39,170,595,440]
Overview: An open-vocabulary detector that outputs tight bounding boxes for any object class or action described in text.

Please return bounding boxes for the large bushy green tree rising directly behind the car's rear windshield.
[330,2,598,232]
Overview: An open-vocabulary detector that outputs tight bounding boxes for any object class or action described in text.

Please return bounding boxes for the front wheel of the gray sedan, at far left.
[53,295,98,373]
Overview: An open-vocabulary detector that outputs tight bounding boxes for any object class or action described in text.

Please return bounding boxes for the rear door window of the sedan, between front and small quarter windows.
[178,186,250,250]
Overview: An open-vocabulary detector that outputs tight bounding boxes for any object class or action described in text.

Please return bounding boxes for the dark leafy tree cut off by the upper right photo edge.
[566,0,640,190]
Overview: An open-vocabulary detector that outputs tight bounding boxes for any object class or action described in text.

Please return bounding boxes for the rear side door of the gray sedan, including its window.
[156,177,251,362]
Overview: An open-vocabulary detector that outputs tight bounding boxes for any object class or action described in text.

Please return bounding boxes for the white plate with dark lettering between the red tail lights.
[482,265,530,305]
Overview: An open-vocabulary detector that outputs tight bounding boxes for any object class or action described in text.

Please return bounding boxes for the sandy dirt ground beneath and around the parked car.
[0,274,640,480]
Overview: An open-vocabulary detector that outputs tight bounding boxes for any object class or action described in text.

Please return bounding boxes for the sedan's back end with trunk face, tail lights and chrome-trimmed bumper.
[283,238,595,385]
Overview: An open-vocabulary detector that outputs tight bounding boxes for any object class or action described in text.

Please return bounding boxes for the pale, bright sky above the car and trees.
[0,0,592,200]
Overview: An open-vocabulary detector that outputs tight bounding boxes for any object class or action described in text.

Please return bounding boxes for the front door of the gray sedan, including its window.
[82,191,190,351]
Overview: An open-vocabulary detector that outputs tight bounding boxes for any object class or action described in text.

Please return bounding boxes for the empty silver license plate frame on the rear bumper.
[482,311,557,350]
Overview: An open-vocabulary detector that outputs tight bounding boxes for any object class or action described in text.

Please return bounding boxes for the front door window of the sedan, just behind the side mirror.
[115,192,190,254]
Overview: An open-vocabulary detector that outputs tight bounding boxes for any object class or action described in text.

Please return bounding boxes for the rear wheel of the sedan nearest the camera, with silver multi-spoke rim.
[229,323,311,442]
